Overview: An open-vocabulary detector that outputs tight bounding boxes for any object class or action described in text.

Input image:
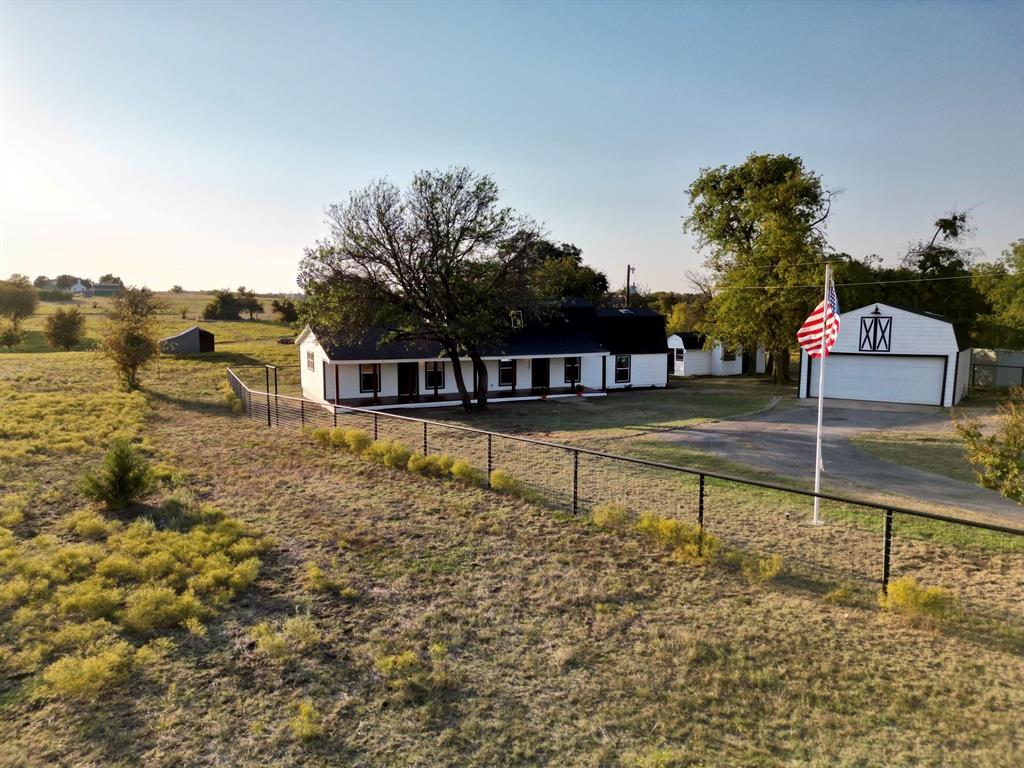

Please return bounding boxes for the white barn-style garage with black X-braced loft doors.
[799,302,971,407]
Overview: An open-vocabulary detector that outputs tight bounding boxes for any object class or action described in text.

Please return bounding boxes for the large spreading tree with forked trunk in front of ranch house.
[299,168,540,410]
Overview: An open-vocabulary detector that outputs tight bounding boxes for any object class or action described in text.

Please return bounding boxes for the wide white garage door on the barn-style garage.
[804,354,945,406]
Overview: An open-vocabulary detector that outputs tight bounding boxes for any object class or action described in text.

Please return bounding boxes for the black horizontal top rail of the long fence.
[227,368,1024,537]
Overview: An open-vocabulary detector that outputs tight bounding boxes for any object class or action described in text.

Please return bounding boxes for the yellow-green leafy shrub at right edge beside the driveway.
[956,387,1024,504]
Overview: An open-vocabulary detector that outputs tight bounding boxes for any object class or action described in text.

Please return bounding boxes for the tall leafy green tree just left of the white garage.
[685,155,833,382]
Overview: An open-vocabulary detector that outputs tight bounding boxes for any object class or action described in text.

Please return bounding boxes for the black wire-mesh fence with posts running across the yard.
[227,369,1024,626]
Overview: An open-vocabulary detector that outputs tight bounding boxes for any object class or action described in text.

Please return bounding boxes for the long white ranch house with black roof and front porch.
[295,304,668,409]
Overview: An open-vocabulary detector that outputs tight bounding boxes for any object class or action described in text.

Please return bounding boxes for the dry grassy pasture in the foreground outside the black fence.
[0,327,1024,768]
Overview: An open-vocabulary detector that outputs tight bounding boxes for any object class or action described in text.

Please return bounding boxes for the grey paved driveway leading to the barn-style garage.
[662,399,1024,525]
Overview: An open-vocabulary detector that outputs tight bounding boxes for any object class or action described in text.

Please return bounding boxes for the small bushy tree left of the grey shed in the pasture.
[99,288,163,390]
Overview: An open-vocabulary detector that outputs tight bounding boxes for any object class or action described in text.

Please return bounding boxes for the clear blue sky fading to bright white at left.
[0,0,1024,291]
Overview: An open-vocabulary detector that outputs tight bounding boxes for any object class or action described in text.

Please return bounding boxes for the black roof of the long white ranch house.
[313,302,669,360]
